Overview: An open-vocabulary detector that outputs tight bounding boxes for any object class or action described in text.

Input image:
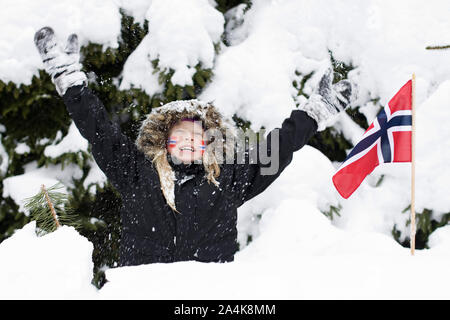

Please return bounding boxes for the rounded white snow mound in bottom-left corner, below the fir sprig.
[0,221,96,299]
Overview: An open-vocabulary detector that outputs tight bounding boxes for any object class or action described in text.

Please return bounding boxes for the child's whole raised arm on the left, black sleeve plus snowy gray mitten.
[34,27,145,193]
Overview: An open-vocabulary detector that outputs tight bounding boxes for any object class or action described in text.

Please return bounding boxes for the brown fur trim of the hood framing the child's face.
[136,99,235,211]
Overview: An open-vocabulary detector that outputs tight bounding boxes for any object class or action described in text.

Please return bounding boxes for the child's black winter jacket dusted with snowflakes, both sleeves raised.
[63,86,317,266]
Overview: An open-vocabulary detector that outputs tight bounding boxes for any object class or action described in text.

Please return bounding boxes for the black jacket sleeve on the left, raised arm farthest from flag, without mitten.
[63,86,144,193]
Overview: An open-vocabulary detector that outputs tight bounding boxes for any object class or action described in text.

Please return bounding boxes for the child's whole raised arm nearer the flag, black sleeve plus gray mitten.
[233,69,355,205]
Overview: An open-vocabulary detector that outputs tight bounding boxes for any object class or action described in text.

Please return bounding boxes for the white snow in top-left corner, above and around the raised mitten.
[0,0,120,84]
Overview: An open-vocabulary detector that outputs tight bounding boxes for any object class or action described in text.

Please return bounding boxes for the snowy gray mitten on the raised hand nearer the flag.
[299,69,356,131]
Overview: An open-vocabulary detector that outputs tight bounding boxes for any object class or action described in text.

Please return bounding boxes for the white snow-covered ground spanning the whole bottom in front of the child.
[0,208,450,300]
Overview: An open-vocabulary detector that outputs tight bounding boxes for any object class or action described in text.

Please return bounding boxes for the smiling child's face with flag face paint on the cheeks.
[167,120,206,163]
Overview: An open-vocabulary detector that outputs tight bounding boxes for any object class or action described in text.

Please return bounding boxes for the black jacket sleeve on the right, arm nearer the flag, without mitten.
[233,110,317,207]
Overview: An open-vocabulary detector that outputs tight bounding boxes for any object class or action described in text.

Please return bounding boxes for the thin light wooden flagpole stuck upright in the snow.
[410,73,416,255]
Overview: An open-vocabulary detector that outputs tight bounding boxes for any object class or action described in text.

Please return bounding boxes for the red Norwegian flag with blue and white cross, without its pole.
[333,80,412,199]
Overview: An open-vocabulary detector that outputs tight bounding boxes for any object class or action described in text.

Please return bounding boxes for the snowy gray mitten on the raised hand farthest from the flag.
[34,27,87,96]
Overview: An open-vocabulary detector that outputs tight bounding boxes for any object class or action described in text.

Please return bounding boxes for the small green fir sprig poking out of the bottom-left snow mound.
[24,182,81,235]
